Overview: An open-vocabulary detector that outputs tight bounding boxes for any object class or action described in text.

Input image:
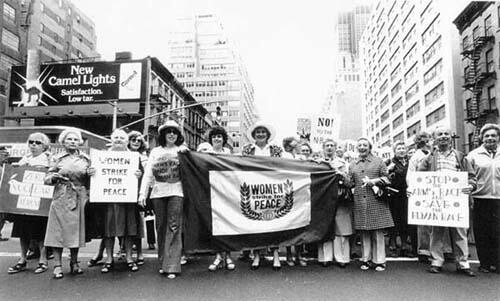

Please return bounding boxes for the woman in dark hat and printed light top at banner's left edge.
[139,120,187,279]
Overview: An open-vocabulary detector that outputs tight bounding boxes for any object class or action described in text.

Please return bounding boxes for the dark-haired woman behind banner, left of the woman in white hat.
[198,126,235,272]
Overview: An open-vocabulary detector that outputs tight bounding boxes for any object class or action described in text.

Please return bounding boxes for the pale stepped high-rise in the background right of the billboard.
[166,15,257,151]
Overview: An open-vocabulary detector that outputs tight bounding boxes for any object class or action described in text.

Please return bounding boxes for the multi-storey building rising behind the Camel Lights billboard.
[0,0,99,124]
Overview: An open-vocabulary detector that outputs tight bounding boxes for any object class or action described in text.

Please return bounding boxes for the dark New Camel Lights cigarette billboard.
[9,62,144,107]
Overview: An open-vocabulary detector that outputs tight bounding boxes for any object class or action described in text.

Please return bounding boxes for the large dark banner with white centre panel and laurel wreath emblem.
[179,152,338,252]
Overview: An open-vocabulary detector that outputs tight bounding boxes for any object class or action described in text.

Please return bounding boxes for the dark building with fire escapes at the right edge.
[453,1,500,151]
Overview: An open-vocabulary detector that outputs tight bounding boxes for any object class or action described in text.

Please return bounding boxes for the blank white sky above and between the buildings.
[72,0,366,141]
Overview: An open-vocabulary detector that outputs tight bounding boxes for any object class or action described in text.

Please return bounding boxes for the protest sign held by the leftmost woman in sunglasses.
[0,164,54,216]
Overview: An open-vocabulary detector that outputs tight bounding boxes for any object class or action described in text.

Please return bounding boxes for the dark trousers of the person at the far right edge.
[473,198,500,269]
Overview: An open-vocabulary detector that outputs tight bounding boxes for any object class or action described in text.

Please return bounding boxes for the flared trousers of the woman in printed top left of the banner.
[152,196,183,274]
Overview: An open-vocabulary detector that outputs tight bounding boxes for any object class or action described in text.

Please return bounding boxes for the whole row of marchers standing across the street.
[1,120,500,279]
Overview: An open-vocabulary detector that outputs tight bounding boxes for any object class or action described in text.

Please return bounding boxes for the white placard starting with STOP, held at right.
[408,171,469,228]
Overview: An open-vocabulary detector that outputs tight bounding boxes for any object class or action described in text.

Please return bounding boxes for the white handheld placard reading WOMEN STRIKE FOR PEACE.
[90,149,139,203]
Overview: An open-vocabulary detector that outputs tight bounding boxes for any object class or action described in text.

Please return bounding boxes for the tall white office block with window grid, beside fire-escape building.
[360,0,464,150]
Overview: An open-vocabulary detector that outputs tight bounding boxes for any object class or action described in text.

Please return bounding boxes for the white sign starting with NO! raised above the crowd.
[311,114,339,149]
